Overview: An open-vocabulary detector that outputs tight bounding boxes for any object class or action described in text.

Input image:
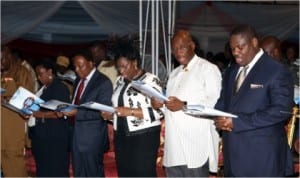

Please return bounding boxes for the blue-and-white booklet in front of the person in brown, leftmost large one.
[2,87,45,114]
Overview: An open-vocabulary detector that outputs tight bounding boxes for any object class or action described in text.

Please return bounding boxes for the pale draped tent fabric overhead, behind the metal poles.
[1,1,299,51]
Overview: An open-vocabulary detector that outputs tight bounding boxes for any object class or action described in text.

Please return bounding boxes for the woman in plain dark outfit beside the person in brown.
[29,59,70,177]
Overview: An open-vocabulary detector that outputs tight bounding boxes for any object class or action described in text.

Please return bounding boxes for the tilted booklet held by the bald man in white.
[131,80,169,101]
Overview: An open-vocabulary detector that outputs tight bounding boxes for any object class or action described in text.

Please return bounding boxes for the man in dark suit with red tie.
[65,50,113,177]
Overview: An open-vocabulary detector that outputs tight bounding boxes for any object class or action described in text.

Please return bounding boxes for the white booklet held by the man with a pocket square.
[183,105,238,118]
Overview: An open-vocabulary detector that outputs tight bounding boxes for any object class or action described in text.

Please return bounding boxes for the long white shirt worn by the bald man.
[163,55,222,172]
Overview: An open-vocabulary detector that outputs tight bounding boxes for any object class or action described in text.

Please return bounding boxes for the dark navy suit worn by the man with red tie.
[73,70,113,177]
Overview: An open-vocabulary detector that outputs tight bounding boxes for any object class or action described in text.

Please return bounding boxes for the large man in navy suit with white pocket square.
[215,25,293,177]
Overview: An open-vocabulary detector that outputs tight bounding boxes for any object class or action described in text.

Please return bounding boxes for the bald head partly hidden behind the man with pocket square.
[260,36,281,61]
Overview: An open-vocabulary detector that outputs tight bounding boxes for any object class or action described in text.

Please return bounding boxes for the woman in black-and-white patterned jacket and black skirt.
[102,40,163,177]
